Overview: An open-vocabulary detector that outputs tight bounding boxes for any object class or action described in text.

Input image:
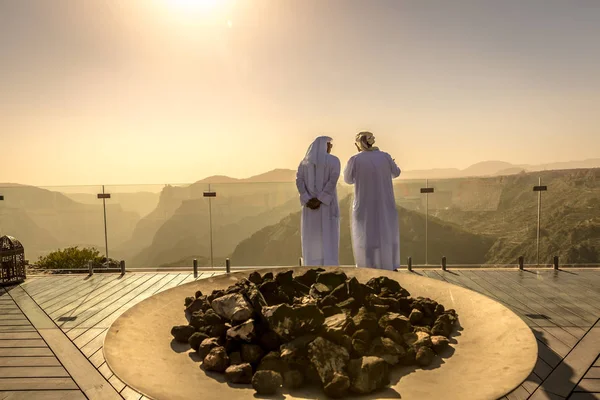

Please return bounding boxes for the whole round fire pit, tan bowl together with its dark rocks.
[104,268,537,400]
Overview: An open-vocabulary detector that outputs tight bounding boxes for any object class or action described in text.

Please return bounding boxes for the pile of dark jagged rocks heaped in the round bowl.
[171,268,457,398]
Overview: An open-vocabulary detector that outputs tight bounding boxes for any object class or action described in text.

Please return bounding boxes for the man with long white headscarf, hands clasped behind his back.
[296,136,340,266]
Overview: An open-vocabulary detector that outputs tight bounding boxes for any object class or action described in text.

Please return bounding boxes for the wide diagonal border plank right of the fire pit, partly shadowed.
[543,323,600,397]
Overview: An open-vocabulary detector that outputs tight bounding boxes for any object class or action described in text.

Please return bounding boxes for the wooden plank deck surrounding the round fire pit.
[0,269,600,400]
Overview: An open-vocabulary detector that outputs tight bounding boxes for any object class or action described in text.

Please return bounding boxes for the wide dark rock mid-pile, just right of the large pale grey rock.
[263,304,325,341]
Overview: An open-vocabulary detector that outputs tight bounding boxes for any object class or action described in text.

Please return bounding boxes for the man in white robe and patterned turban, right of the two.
[344,132,400,270]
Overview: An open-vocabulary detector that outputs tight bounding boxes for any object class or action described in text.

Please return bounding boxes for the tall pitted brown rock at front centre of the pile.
[308,337,350,385]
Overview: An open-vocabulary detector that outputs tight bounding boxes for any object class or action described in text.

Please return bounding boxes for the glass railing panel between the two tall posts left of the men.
[105,183,210,271]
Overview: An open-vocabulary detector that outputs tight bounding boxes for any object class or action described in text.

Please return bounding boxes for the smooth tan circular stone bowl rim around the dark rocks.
[104,267,537,400]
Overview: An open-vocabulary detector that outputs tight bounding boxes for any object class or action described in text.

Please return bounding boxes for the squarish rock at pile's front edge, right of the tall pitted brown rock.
[348,357,390,394]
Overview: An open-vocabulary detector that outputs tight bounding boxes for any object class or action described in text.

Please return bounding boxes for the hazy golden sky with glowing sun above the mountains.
[0,0,600,185]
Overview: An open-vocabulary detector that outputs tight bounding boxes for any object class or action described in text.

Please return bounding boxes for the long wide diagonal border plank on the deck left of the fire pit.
[5,288,121,400]
